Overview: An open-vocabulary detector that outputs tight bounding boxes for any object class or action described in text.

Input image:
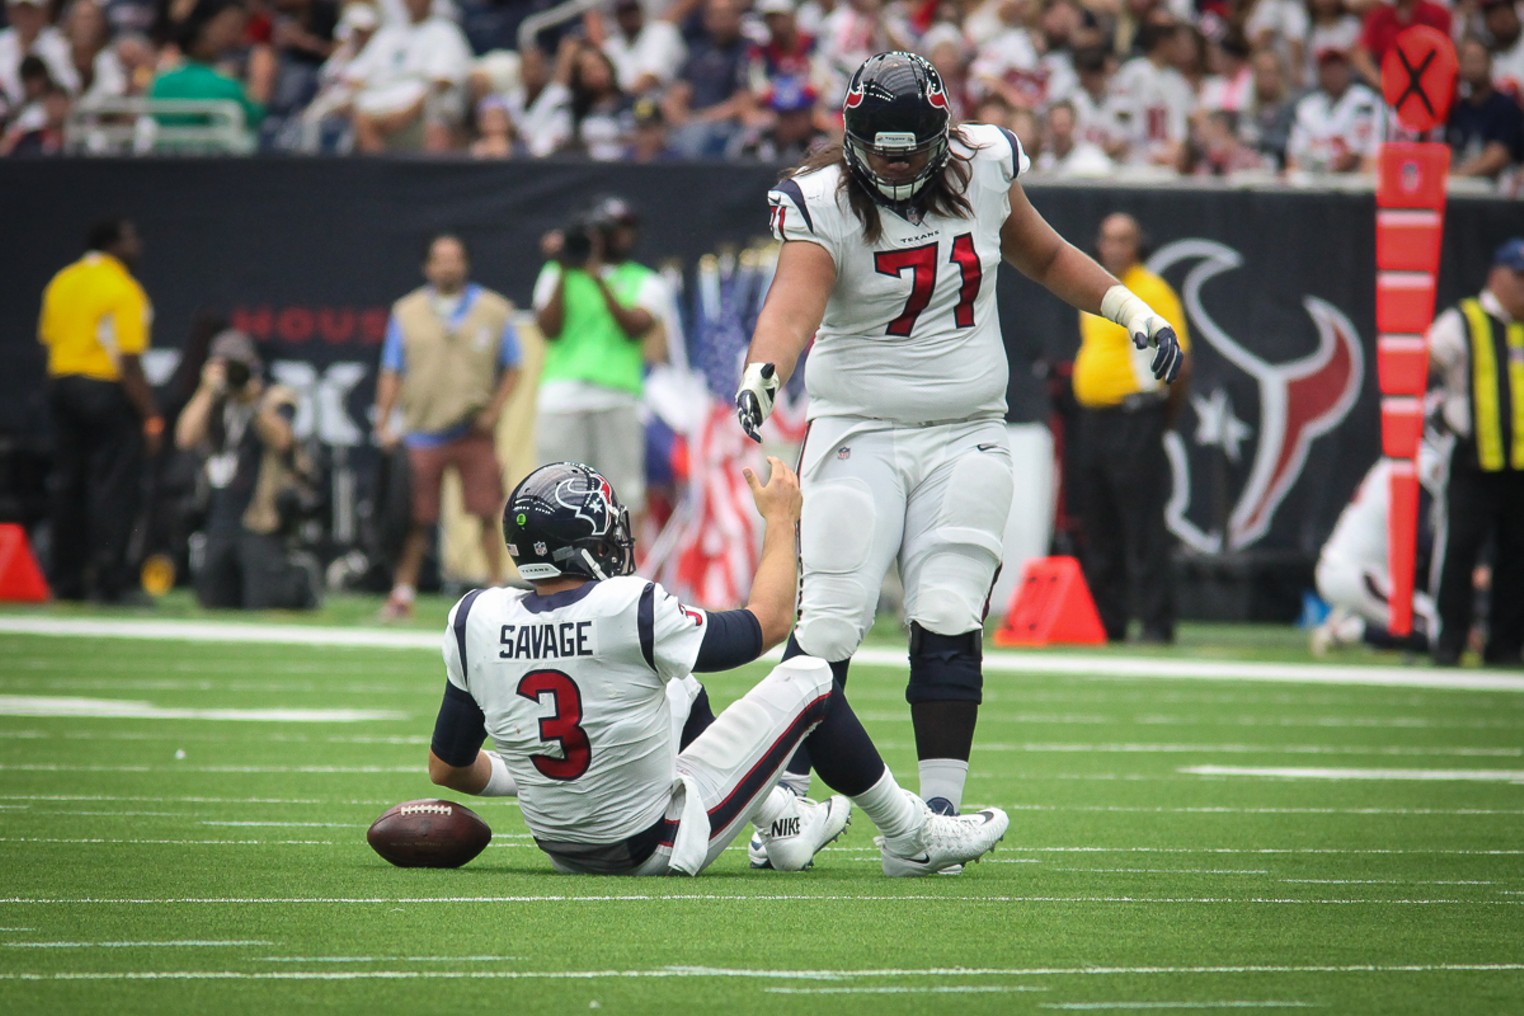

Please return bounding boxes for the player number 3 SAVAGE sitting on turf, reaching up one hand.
[428,458,1009,876]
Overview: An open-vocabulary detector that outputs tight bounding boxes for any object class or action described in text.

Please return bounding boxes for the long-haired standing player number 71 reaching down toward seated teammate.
[736,53,1181,840]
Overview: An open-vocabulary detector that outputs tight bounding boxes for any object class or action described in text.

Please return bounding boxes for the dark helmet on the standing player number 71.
[841,53,953,204]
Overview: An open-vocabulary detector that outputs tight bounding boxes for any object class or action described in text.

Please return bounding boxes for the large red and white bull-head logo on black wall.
[1148,239,1364,553]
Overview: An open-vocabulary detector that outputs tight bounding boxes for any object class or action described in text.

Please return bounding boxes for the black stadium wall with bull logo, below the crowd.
[0,158,1524,615]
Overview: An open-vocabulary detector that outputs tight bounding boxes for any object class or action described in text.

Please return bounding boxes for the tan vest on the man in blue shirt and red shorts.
[392,286,514,434]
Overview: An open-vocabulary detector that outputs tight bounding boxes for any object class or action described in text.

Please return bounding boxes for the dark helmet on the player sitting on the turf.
[503,462,636,579]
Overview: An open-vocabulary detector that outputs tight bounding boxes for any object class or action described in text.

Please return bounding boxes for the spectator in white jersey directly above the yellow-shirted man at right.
[1113,21,1196,168]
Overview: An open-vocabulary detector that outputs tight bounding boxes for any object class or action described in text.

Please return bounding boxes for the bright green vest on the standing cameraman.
[541,260,655,396]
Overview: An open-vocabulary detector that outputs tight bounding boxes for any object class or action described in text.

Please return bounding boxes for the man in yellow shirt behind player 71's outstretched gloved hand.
[1070,213,1190,643]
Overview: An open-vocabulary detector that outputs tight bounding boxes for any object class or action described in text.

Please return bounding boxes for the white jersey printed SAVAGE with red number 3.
[443,576,707,844]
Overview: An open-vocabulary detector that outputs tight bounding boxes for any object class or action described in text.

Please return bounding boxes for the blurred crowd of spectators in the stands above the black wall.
[0,0,1524,186]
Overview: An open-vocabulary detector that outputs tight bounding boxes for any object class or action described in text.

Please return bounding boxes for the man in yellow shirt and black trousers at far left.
[37,219,165,603]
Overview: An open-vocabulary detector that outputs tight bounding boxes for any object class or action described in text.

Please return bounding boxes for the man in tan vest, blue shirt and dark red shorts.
[375,233,520,620]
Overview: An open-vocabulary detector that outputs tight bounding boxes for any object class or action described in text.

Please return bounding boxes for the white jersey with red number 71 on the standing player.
[768,123,1027,423]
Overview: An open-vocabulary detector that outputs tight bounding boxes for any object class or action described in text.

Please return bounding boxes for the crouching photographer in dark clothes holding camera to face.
[175,331,319,611]
